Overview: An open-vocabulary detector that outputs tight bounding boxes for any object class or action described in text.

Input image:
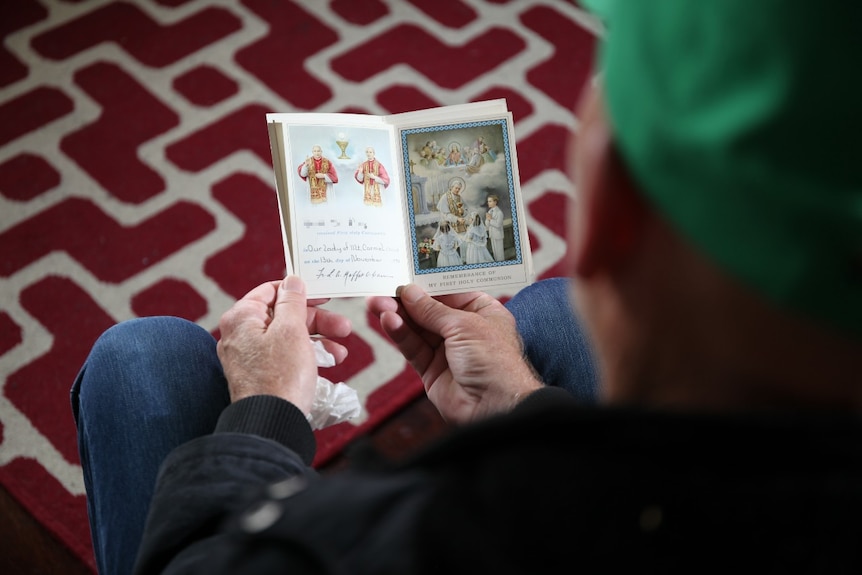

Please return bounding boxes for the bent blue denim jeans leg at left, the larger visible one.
[71,317,230,575]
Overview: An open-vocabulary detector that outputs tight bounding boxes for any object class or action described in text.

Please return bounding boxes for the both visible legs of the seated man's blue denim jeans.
[71,279,596,575]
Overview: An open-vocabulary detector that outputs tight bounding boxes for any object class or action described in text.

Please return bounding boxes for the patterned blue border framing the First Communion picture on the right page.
[401,118,523,275]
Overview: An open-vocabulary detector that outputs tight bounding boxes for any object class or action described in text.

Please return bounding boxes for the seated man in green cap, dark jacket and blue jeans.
[73,0,862,573]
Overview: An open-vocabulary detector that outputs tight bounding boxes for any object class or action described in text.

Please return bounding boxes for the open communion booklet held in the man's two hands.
[266,100,533,297]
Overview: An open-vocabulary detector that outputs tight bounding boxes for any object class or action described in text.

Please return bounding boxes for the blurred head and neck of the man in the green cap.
[570,0,862,407]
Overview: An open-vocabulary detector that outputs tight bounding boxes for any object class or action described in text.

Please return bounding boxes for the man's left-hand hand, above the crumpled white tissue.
[217,276,351,413]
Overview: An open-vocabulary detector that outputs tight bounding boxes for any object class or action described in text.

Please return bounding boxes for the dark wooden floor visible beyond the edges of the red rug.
[0,396,446,575]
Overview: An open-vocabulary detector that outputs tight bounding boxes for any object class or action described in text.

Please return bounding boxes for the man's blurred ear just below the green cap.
[569,87,648,278]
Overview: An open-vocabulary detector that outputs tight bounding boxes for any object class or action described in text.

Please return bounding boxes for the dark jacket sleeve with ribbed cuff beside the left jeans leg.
[135,396,322,573]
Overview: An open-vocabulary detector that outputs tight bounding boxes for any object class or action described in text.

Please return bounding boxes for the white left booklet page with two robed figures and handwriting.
[282,115,409,297]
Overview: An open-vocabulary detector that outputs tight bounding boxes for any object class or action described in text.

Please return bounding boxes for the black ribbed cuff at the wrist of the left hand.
[215,395,317,465]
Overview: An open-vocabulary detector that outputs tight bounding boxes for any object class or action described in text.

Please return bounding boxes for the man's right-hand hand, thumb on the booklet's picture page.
[368,285,542,423]
